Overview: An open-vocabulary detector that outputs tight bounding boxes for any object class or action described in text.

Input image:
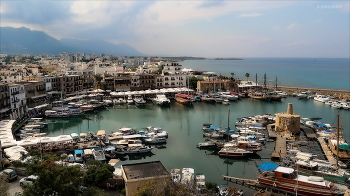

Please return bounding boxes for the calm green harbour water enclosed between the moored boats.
[41,97,350,194]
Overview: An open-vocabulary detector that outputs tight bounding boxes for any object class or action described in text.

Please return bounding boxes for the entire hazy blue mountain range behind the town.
[0,27,147,56]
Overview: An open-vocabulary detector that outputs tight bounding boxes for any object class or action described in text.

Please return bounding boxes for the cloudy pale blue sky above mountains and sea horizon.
[0,0,350,58]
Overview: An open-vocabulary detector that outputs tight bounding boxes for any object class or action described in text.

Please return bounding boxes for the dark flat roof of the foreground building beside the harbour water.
[122,161,170,180]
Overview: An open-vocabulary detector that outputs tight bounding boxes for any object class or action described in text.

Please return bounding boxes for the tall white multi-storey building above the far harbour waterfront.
[162,63,187,88]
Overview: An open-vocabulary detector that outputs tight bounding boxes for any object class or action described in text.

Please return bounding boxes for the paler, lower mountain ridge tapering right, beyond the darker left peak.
[60,39,147,56]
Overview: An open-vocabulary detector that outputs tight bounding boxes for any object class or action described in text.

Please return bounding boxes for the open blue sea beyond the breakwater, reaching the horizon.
[179,58,350,90]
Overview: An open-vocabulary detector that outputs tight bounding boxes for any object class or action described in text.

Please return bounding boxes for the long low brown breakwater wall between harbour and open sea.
[266,86,350,101]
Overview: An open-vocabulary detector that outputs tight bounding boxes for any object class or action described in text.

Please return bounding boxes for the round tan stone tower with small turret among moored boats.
[275,103,300,134]
